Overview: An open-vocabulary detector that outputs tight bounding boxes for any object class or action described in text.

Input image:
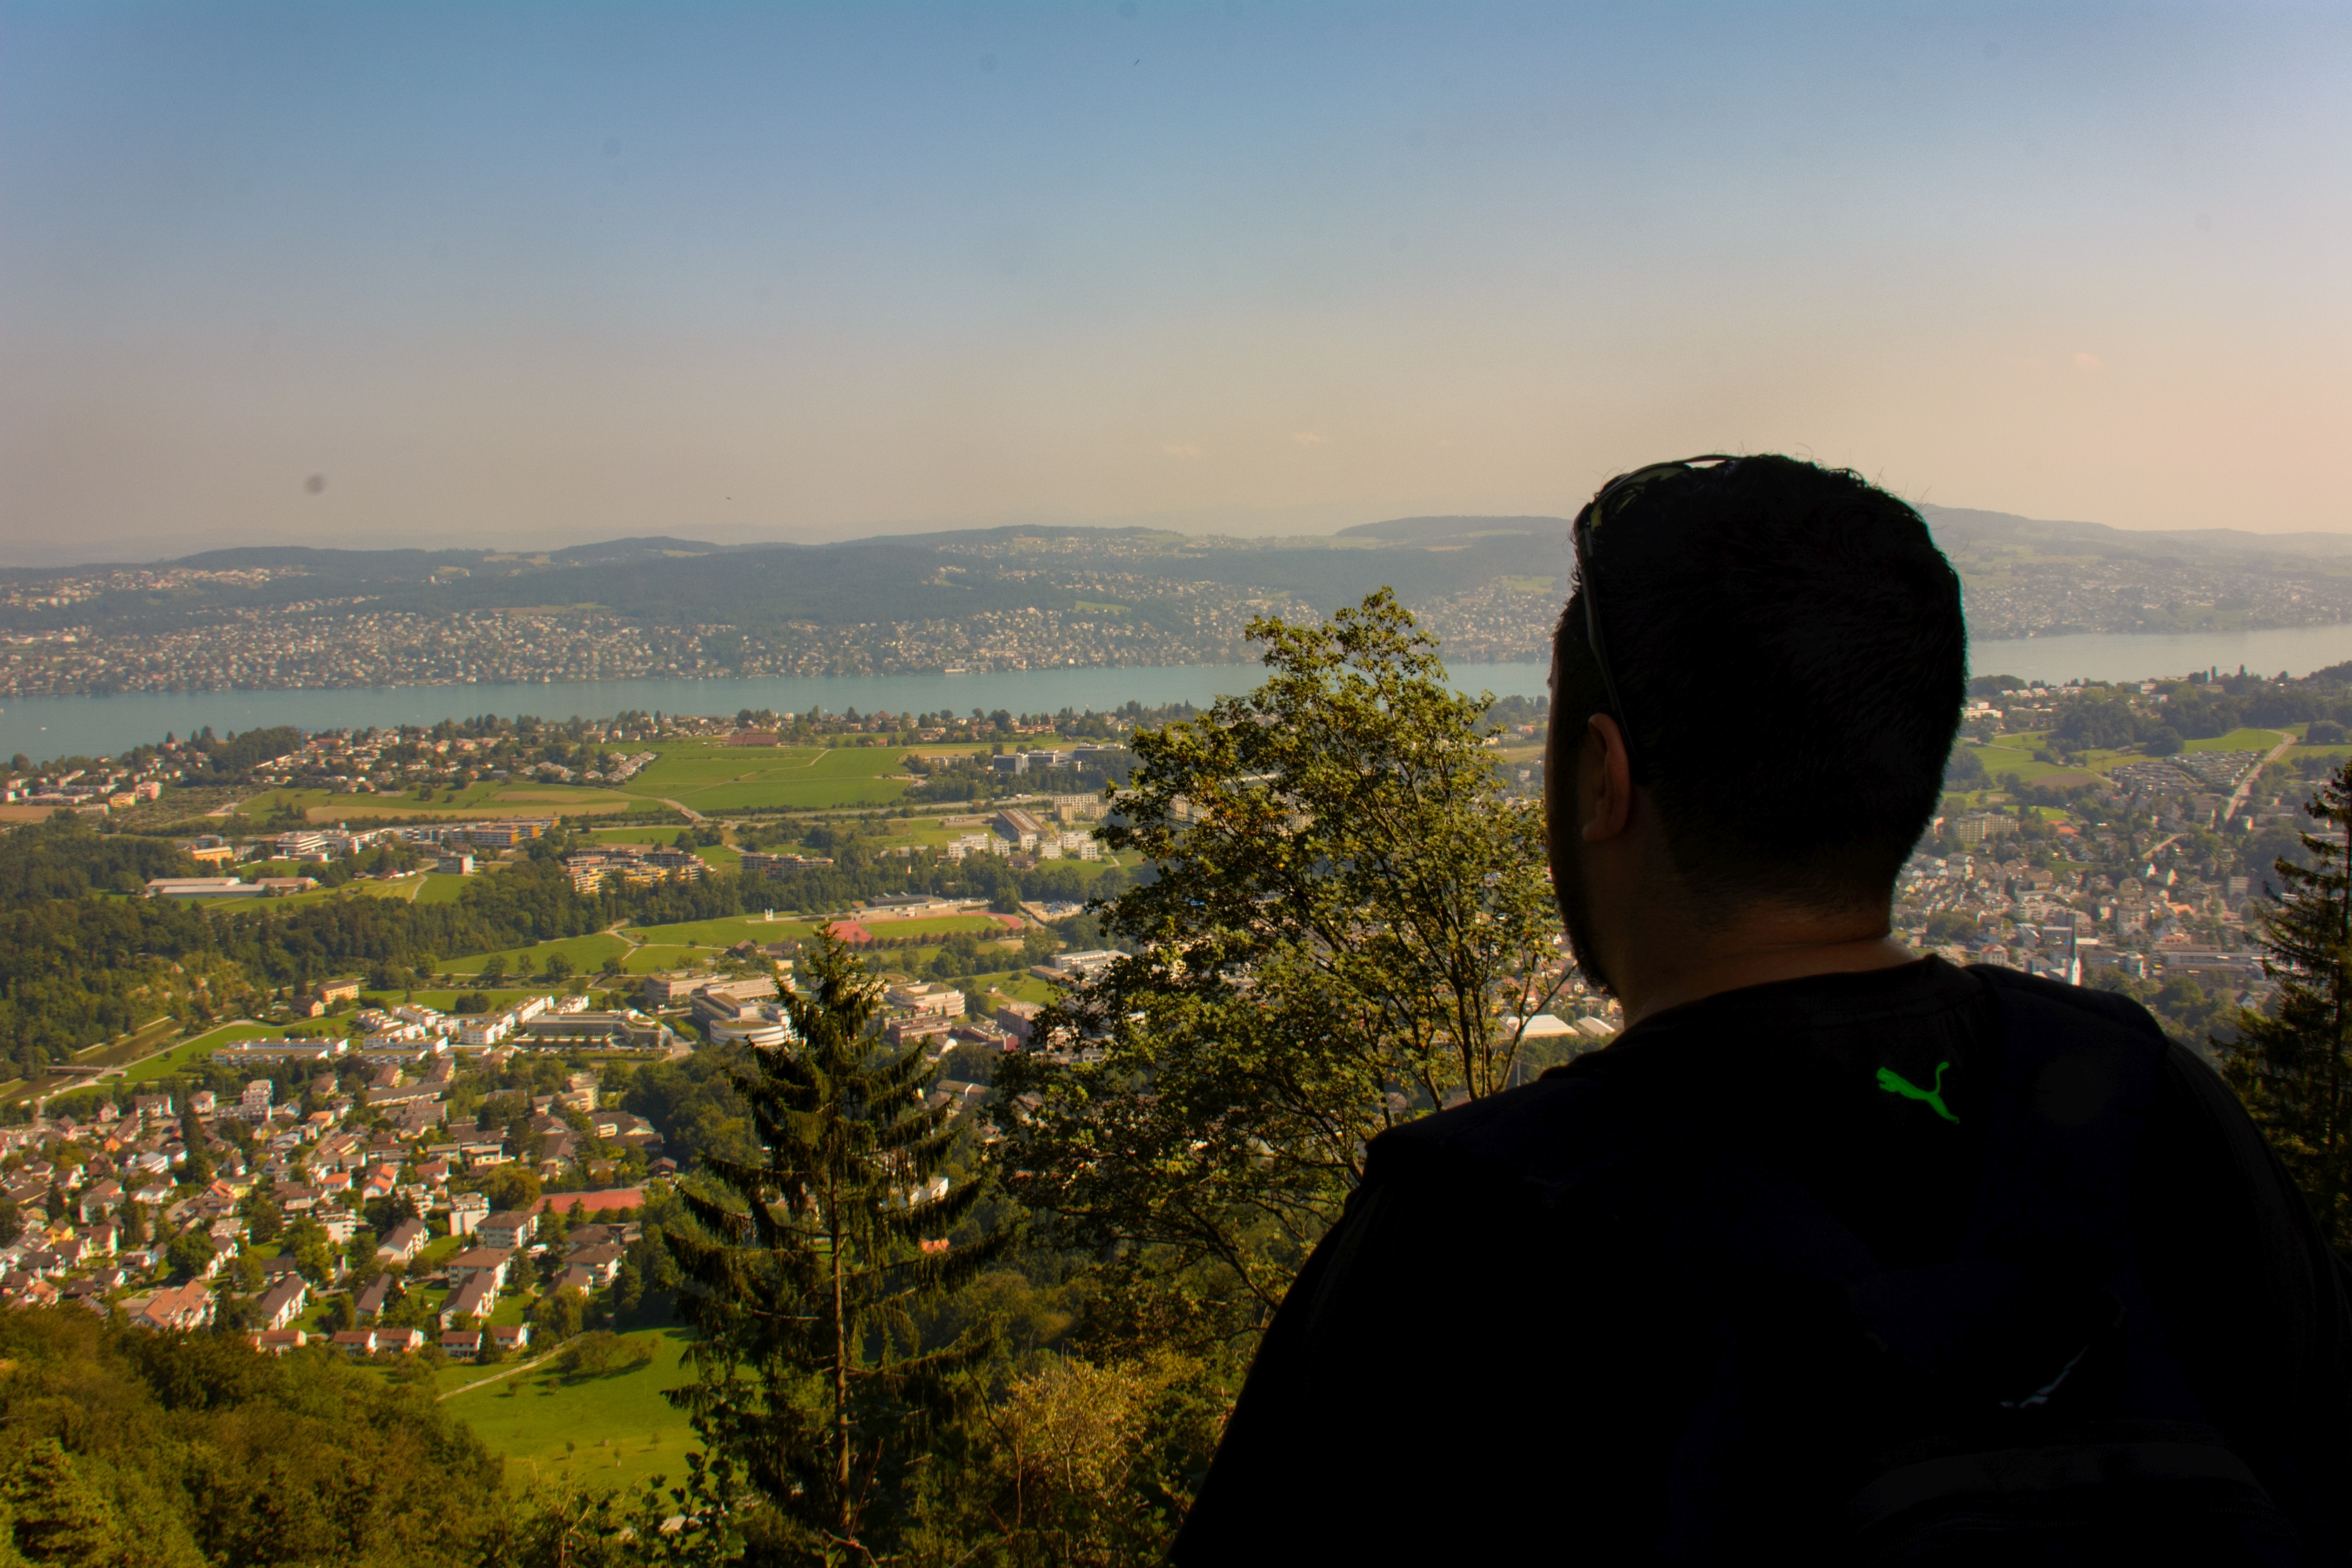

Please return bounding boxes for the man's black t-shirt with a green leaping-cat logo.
[1174,959,2352,1563]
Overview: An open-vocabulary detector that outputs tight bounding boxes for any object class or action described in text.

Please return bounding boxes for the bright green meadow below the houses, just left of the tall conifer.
[445,1328,694,1490]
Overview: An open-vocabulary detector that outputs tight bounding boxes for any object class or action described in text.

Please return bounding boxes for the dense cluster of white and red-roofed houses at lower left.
[0,1018,675,1361]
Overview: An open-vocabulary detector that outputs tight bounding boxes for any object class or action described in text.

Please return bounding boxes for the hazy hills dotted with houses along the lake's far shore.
[0,506,2352,696]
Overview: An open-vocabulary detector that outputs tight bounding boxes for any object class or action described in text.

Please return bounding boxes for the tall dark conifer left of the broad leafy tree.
[666,938,1007,1561]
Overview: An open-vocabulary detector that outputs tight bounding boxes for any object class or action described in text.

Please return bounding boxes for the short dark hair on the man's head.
[1552,456,1969,907]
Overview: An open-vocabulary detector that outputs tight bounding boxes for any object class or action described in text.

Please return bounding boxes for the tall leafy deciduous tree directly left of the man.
[997,593,1564,1345]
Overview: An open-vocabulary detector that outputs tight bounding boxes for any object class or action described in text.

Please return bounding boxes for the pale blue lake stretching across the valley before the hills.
[0,626,2352,762]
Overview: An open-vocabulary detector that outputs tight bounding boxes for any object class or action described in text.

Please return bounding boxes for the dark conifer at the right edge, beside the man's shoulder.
[2227,760,2352,1246]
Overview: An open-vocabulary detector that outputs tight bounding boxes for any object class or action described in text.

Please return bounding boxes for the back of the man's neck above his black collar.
[1618,907,1919,1027]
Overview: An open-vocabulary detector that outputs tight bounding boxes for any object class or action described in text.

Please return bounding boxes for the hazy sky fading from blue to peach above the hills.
[0,0,2352,560]
